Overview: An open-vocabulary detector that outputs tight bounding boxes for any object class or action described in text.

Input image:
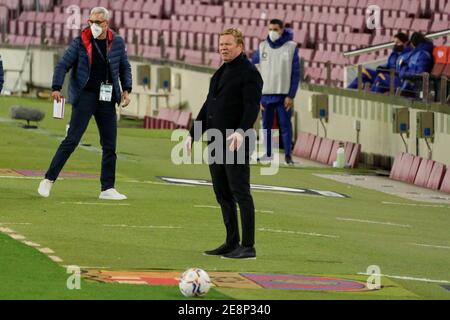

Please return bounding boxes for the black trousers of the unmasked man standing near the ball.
[209,163,255,247]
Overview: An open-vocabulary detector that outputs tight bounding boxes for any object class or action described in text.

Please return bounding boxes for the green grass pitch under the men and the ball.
[0,97,450,299]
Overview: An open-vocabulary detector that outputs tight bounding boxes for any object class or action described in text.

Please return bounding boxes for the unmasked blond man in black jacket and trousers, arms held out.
[186,29,263,259]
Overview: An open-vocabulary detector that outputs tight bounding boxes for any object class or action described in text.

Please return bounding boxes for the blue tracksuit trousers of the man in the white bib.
[262,100,292,156]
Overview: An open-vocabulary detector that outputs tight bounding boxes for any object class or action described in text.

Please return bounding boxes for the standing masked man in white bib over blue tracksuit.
[252,19,300,165]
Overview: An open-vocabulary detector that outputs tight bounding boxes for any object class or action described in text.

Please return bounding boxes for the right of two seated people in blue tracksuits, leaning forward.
[399,32,434,95]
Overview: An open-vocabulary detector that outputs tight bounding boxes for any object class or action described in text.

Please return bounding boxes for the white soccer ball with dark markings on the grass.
[178,268,211,297]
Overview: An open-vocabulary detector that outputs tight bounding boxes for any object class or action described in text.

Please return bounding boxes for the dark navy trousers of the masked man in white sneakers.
[45,91,117,191]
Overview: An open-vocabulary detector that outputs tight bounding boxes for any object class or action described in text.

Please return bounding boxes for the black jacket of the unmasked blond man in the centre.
[190,54,263,140]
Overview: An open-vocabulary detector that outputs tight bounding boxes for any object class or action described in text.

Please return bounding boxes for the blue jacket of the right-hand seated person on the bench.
[399,41,433,80]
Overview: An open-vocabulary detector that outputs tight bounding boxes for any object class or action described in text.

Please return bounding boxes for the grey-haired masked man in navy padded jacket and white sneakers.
[38,7,132,200]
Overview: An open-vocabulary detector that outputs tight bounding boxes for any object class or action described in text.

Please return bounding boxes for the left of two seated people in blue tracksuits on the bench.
[347,32,409,93]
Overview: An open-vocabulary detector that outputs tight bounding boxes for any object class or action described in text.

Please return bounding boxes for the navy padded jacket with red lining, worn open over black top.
[52,28,132,104]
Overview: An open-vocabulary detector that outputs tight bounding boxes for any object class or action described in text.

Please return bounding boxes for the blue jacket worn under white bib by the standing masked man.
[252,28,300,101]
